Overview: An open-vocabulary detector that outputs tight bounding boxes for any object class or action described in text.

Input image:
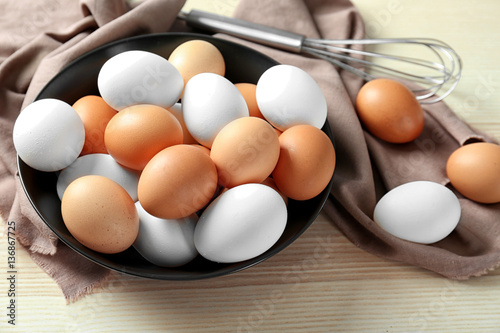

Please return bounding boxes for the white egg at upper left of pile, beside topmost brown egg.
[97,50,184,110]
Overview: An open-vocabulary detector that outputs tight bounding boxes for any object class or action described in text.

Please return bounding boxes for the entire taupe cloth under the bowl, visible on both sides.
[0,0,500,301]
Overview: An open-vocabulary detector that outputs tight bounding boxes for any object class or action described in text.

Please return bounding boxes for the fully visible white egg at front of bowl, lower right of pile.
[194,184,288,263]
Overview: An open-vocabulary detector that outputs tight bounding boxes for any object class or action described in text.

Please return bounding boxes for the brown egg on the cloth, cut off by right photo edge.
[446,142,500,204]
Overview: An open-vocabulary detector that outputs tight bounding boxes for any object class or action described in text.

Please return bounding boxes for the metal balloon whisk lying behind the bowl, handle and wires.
[178,10,462,104]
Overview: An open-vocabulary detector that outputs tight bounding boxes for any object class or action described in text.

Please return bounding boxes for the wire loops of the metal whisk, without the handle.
[302,38,461,104]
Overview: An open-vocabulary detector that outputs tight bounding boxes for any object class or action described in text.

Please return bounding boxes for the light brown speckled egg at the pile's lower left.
[61,175,139,253]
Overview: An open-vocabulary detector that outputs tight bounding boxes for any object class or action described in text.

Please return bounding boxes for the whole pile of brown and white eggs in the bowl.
[13,40,336,267]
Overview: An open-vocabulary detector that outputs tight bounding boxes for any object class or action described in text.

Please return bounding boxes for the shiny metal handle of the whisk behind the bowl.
[178,10,305,53]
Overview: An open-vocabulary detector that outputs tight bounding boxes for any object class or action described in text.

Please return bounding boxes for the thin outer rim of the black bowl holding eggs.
[16,32,335,281]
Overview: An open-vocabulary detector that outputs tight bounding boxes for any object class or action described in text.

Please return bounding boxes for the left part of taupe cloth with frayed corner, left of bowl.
[0,0,184,302]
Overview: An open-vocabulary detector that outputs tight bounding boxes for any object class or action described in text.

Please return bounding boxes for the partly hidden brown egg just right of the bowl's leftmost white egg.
[73,95,117,155]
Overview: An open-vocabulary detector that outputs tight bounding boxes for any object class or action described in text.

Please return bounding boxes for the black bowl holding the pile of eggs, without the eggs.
[17,33,333,280]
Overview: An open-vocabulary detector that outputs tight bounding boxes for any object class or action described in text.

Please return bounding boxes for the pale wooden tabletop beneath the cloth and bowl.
[0,0,500,333]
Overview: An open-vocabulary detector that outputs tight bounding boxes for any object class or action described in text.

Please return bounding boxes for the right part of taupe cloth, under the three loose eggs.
[228,0,500,279]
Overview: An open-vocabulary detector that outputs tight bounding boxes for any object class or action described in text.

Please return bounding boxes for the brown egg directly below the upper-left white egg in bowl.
[104,104,183,170]
